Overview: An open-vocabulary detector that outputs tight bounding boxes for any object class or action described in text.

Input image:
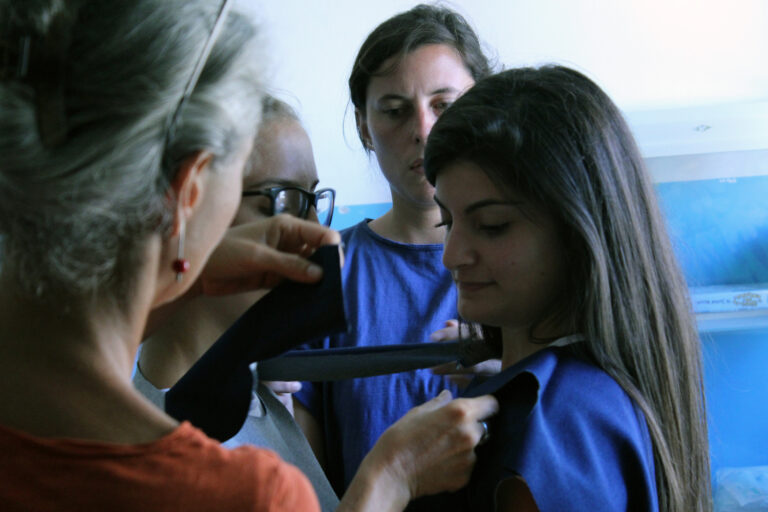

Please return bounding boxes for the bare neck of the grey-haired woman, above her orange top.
[0,244,176,443]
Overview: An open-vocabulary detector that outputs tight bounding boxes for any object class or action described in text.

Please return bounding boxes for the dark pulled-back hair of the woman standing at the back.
[349,4,491,147]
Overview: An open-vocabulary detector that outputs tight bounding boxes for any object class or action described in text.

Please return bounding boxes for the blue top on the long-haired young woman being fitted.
[444,342,658,512]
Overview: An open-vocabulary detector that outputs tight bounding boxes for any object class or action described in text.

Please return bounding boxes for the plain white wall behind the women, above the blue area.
[248,0,768,205]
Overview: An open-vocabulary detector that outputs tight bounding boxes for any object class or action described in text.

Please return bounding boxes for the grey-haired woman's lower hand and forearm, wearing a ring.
[337,391,498,512]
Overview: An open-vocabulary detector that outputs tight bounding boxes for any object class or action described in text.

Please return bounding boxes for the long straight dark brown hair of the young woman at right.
[425,66,711,512]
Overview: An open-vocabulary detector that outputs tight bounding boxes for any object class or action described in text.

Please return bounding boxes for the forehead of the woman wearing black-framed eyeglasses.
[243,118,317,188]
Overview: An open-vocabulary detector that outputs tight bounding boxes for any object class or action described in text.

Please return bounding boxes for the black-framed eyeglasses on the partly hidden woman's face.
[243,187,336,226]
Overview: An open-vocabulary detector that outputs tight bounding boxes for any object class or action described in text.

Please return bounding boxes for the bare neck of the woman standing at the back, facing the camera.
[369,194,445,244]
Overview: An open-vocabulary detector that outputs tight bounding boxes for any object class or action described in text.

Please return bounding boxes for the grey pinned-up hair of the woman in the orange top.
[0,0,263,300]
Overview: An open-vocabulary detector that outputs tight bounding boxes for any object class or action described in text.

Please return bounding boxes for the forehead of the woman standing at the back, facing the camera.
[368,44,474,100]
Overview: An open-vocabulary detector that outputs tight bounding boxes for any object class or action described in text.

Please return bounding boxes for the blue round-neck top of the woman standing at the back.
[295,220,458,495]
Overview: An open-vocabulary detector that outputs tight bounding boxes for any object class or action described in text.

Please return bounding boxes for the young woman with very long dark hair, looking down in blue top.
[425,66,711,512]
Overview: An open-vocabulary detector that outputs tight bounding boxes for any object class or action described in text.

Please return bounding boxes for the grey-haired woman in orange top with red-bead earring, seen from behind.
[0,0,496,512]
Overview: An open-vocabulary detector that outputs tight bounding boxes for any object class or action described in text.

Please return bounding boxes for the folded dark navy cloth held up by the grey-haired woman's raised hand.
[170,246,347,441]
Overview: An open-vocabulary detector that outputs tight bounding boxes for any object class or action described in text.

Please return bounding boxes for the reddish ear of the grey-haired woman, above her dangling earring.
[168,151,213,236]
